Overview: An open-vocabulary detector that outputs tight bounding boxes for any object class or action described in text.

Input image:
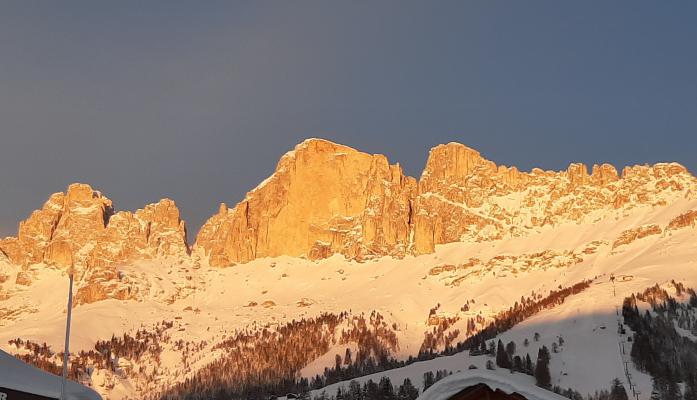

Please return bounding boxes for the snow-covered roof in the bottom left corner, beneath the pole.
[0,350,102,400]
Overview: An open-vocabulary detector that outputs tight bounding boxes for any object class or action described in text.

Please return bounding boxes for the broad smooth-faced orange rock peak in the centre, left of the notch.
[196,139,416,266]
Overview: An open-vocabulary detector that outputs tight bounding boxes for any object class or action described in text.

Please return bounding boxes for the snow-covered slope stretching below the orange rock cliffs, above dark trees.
[0,193,697,399]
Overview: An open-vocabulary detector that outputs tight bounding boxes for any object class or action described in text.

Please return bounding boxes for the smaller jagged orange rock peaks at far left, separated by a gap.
[0,183,188,270]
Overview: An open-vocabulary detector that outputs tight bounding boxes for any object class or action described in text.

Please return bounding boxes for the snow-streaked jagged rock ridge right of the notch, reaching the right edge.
[412,143,697,254]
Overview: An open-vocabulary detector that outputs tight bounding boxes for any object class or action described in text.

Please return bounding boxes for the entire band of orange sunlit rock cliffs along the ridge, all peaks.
[0,139,697,268]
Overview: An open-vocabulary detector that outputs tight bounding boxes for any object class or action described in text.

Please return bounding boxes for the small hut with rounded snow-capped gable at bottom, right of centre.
[418,370,568,400]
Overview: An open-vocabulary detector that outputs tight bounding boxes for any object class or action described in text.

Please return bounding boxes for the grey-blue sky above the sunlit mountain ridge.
[0,0,697,240]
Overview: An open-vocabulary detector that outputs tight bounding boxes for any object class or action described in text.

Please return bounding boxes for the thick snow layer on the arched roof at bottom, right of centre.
[417,370,568,400]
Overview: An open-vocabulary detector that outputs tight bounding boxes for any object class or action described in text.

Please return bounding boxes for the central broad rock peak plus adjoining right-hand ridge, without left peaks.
[195,139,697,266]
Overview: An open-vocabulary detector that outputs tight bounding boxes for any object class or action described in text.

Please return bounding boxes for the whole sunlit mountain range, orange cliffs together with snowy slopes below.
[0,139,697,399]
